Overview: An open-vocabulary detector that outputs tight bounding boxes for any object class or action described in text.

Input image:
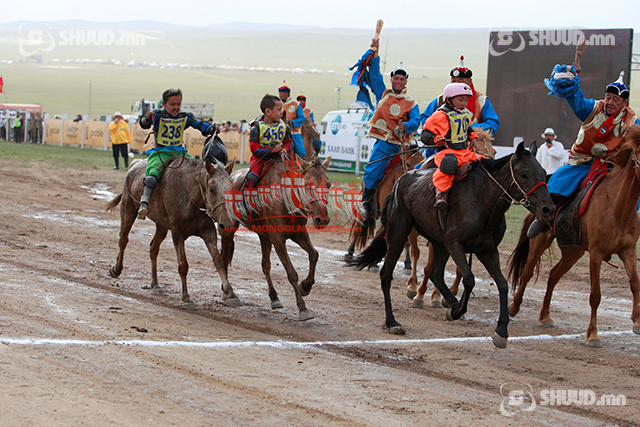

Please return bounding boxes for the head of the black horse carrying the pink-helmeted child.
[508,142,556,222]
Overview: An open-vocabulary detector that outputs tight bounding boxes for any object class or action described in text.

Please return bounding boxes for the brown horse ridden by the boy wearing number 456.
[229,157,331,321]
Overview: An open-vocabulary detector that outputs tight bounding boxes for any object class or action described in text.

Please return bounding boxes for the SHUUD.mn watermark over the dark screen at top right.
[489,30,616,56]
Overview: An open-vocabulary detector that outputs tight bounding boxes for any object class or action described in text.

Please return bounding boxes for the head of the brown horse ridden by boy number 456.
[298,156,331,228]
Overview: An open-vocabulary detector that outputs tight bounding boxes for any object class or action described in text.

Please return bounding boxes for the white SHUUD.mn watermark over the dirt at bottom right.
[500,383,627,417]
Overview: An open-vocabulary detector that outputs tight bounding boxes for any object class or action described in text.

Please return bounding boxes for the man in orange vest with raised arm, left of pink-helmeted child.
[360,39,420,219]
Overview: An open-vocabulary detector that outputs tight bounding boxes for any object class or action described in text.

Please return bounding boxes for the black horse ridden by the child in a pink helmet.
[354,143,555,348]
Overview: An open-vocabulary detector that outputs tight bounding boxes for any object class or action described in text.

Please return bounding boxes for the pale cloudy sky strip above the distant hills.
[0,0,640,29]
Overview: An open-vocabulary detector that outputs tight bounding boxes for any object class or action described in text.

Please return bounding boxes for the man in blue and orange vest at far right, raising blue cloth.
[527,65,640,239]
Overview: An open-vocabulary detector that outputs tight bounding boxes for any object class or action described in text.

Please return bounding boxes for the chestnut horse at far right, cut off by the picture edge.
[508,126,640,347]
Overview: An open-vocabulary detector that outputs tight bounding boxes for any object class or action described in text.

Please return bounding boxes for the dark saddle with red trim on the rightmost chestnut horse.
[554,158,609,248]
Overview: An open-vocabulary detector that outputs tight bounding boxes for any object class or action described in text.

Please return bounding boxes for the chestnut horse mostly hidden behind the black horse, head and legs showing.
[407,128,496,308]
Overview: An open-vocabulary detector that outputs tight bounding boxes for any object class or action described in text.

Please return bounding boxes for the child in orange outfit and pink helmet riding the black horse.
[421,83,478,210]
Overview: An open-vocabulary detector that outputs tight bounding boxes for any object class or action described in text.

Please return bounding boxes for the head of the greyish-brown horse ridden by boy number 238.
[203,159,235,228]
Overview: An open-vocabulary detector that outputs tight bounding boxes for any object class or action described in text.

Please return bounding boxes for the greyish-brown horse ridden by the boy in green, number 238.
[106,157,240,310]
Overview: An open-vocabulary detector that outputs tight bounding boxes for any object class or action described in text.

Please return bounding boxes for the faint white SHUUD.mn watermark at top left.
[18,24,146,56]
